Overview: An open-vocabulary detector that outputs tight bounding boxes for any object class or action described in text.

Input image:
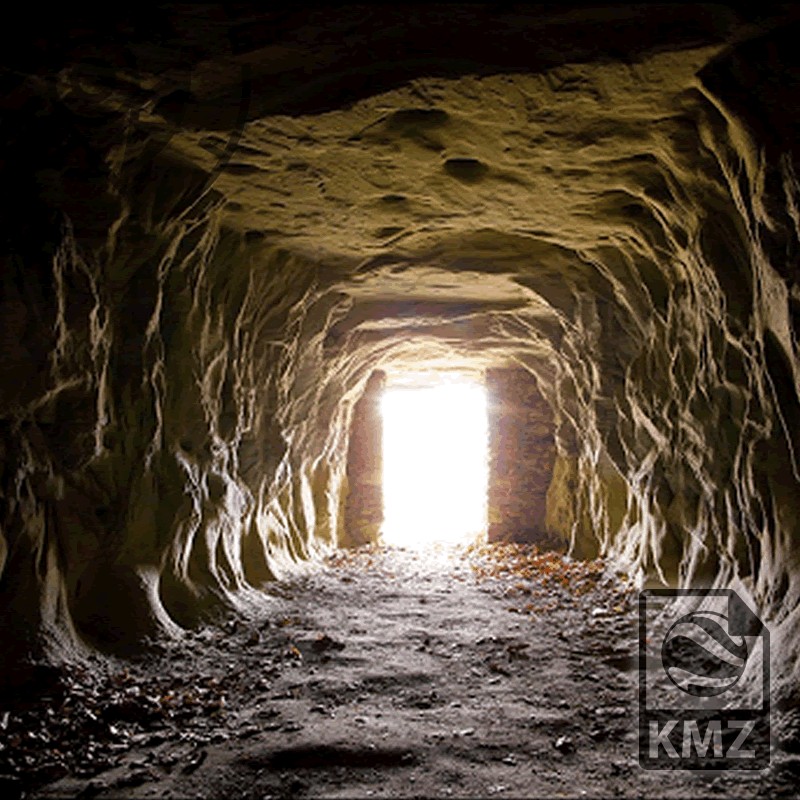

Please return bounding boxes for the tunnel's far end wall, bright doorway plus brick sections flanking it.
[339,367,566,549]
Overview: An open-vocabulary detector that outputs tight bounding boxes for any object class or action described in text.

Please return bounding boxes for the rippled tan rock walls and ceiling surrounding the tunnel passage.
[0,4,800,708]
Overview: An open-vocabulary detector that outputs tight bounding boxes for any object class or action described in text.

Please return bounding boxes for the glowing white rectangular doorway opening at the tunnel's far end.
[382,380,489,547]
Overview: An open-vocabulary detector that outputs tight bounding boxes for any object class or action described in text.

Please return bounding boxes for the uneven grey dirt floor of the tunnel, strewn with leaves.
[0,546,797,798]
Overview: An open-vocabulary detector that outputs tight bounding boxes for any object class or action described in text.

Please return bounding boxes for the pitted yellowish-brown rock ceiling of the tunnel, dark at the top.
[41,4,791,374]
